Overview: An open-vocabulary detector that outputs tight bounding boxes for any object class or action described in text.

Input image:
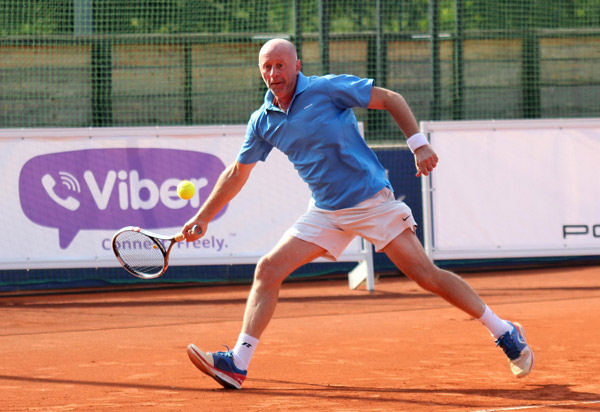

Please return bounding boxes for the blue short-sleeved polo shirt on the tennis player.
[238,73,391,210]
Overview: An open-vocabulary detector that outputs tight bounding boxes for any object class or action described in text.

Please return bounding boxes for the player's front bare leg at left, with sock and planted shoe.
[188,236,326,389]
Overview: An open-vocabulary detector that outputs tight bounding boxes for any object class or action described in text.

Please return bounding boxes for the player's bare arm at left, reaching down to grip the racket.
[181,161,256,242]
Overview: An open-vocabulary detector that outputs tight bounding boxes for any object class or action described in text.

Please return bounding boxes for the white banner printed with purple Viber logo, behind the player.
[0,126,370,269]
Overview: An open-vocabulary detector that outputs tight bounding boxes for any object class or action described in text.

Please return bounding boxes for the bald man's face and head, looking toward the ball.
[258,44,300,100]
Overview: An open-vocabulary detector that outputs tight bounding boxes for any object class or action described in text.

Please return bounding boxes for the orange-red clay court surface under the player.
[0,267,600,412]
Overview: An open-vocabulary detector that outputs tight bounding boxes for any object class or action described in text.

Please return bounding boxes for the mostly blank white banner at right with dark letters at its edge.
[421,119,600,260]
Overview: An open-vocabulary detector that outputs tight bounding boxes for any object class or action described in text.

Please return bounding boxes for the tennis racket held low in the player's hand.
[112,225,202,279]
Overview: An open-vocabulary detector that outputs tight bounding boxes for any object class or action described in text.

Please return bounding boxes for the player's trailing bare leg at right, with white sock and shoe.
[383,229,534,378]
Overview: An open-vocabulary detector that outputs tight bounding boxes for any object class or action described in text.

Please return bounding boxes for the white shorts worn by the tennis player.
[286,188,417,260]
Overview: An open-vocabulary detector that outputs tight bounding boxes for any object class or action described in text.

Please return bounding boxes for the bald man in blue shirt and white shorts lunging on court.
[182,39,534,389]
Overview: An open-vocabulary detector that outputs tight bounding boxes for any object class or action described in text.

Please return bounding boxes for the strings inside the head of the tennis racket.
[115,231,165,276]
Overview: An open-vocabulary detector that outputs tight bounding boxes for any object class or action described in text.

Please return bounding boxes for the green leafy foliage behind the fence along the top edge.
[0,0,600,36]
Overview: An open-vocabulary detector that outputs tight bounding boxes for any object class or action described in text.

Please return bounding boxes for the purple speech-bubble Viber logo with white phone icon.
[19,149,226,249]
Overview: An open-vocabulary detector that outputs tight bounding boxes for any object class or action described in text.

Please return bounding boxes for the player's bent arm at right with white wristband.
[368,86,438,177]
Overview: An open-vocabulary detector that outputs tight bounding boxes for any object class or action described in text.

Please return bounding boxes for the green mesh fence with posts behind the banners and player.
[0,0,600,142]
